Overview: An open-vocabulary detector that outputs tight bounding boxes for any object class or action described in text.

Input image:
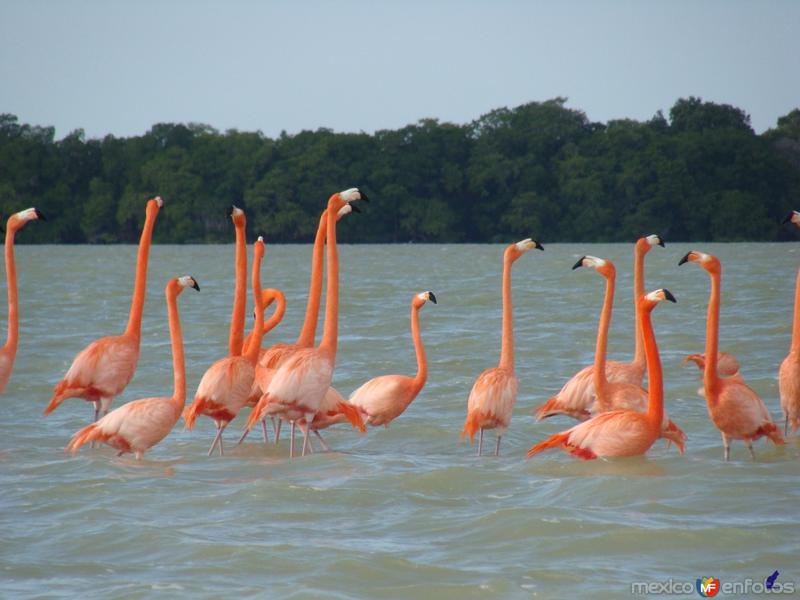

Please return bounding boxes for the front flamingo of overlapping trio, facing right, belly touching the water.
[528,289,675,460]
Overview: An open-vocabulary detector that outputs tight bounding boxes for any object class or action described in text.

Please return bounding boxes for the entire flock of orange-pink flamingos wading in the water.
[0,188,800,460]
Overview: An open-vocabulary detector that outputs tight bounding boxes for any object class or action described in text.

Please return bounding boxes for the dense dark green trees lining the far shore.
[0,98,800,243]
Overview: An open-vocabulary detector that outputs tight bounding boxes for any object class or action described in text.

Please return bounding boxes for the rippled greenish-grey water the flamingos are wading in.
[0,244,800,599]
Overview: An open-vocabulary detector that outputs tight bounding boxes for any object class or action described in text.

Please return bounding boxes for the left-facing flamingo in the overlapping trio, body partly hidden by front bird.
[572,256,686,454]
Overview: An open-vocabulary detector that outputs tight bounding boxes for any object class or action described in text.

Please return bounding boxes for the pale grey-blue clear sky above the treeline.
[0,0,800,138]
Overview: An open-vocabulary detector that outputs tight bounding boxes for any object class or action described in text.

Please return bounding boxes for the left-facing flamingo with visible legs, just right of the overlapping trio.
[678,250,784,461]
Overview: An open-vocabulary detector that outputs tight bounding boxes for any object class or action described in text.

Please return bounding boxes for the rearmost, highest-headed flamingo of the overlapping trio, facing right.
[536,234,665,421]
